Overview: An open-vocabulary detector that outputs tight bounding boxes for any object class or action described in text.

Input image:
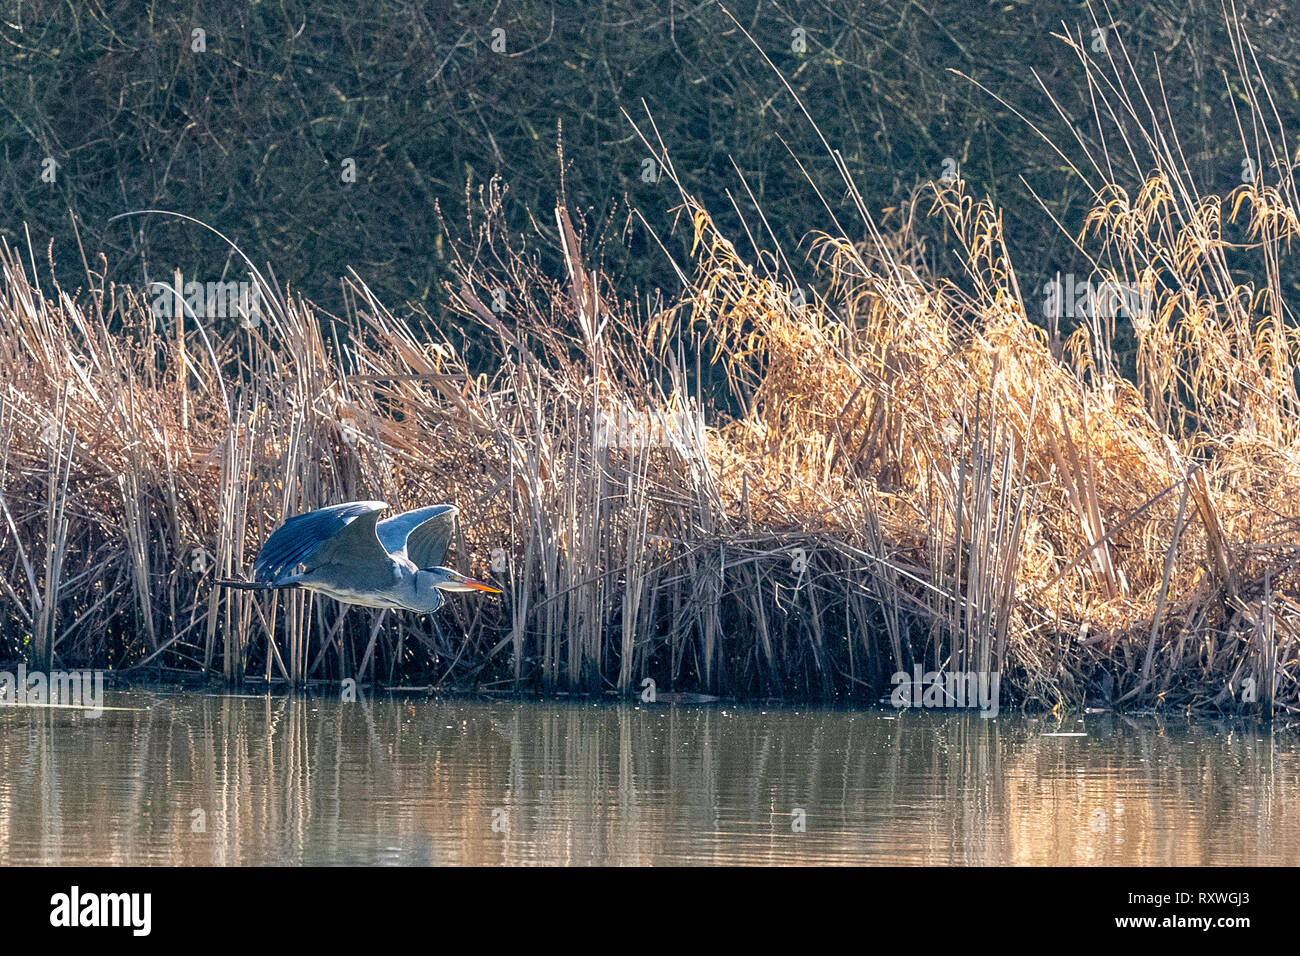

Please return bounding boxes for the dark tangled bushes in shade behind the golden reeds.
[0,0,1300,325]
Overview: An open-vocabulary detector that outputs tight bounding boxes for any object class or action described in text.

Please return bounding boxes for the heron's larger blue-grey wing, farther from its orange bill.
[252,501,389,584]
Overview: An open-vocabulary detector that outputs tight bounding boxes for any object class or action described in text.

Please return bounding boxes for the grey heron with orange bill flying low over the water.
[217,501,501,611]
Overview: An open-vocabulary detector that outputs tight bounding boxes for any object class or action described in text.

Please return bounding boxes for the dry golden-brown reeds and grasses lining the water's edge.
[0,14,1300,717]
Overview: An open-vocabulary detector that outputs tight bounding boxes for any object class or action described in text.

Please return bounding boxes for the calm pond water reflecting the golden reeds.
[0,689,1300,865]
